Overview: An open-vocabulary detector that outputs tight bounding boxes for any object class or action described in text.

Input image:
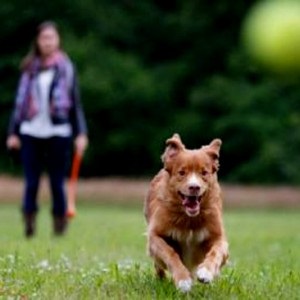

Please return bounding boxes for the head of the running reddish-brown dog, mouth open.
[162,134,222,217]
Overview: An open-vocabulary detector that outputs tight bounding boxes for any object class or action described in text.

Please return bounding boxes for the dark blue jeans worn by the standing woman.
[21,135,71,216]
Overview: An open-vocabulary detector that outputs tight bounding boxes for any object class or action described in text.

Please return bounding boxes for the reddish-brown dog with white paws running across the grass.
[144,134,228,292]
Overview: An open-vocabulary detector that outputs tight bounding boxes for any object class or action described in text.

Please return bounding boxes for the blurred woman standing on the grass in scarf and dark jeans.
[6,22,88,237]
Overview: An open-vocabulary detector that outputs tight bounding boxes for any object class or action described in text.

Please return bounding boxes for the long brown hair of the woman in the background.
[20,21,59,71]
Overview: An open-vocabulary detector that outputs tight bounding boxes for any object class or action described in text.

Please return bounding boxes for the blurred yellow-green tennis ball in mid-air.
[242,0,300,73]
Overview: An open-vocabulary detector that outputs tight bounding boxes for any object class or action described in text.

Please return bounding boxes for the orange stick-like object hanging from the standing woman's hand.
[67,152,82,218]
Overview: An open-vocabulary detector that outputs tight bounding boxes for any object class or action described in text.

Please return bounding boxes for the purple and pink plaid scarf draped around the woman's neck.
[16,51,74,122]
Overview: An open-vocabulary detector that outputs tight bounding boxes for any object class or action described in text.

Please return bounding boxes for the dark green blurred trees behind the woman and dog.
[0,0,300,184]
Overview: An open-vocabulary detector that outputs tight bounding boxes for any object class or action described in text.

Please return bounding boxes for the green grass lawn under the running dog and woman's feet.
[0,201,300,299]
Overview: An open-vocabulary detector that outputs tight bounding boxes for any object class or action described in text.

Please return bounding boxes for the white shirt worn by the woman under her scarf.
[20,69,72,138]
